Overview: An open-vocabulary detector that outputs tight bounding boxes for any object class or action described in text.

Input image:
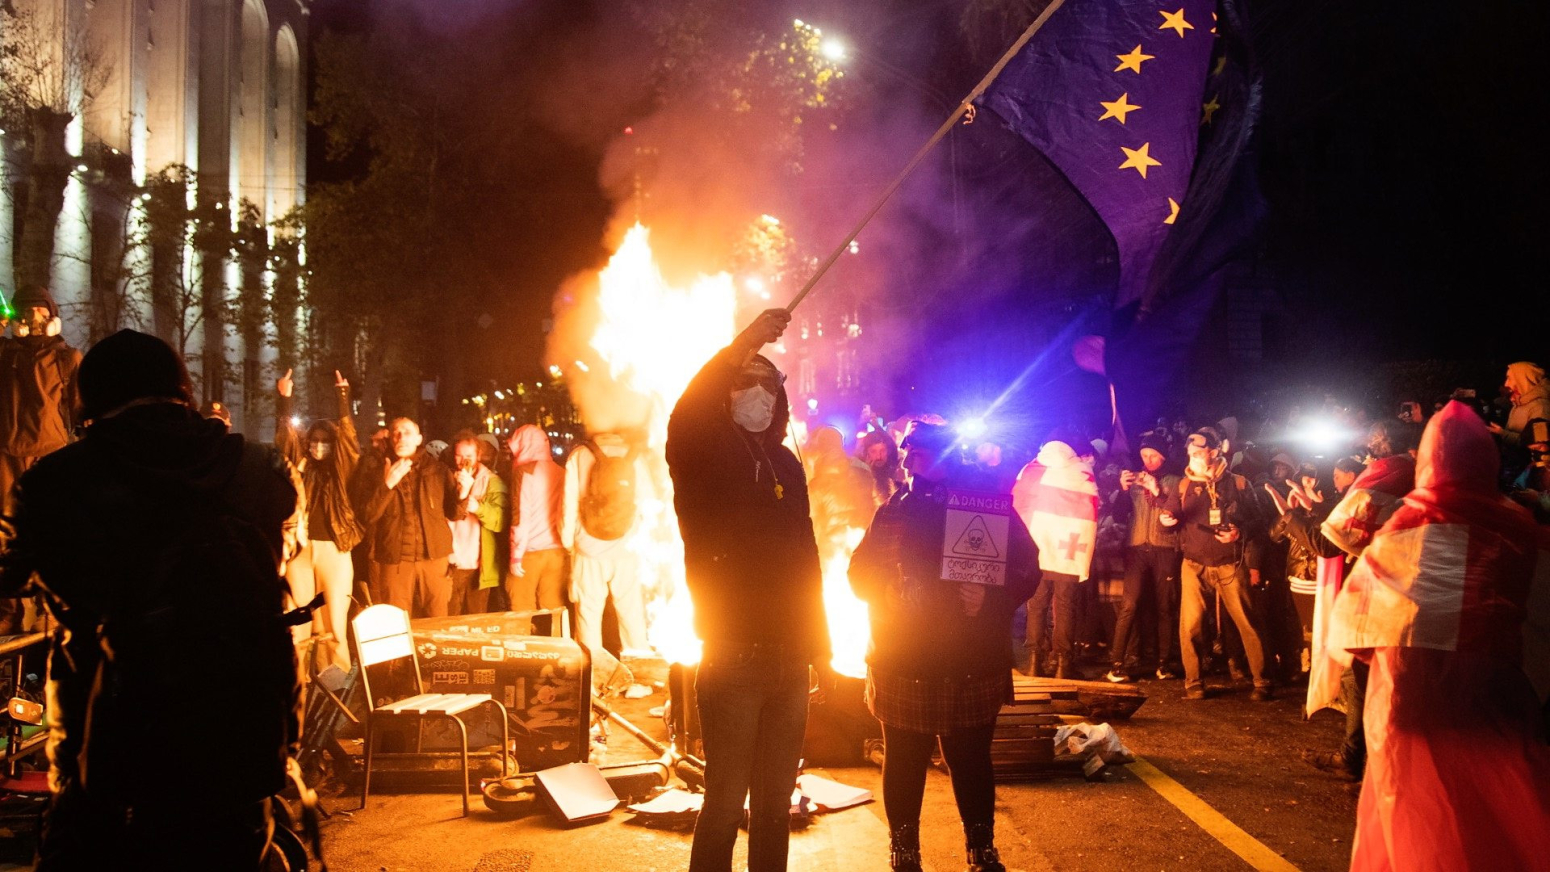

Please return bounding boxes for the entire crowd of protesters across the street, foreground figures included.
[0,293,1550,872]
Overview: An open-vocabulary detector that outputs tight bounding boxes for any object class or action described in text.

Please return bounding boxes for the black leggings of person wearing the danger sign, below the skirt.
[882,723,995,829]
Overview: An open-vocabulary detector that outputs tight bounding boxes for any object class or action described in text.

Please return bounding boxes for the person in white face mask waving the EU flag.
[667,308,829,872]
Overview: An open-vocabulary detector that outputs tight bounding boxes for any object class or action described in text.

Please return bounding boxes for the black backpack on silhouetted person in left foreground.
[79,458,299,805]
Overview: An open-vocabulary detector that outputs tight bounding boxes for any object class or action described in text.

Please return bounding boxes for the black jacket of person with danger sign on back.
[849,479,1039,678]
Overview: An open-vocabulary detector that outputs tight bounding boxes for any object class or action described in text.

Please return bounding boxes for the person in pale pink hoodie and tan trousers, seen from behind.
[505,424,566,631]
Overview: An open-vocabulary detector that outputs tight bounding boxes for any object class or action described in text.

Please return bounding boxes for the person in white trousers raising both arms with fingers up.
[274,369,364,672]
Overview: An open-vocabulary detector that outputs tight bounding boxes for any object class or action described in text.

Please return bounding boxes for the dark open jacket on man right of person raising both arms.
[353,451,457,564]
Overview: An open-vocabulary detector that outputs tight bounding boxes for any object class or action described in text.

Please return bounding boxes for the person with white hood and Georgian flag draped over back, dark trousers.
[1012,440,1097,678]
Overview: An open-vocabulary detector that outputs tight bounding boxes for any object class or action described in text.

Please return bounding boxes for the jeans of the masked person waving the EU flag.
[688,644,808,872]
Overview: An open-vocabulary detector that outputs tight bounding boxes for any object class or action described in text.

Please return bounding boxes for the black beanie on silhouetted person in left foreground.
[78,330,194,421]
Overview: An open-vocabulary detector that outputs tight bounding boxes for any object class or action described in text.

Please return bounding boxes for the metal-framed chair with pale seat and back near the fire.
[350,604,512,818]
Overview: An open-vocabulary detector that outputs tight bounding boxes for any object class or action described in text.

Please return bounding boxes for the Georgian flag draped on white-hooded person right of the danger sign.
[1012,441,1097,581]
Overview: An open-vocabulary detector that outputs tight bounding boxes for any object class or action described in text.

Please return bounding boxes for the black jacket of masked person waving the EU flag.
[667,348,829,663]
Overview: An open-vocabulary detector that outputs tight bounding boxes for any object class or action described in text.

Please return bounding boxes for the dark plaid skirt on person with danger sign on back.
[866,668,1012,736]
